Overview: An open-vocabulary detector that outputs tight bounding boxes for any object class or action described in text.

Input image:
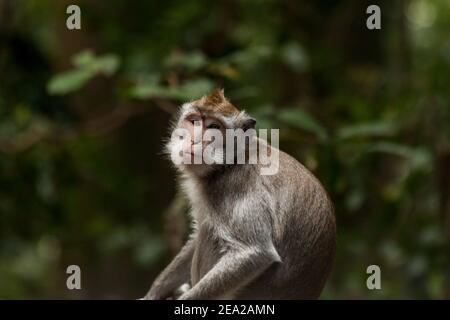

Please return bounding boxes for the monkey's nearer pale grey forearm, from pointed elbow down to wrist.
[179,246,281,300]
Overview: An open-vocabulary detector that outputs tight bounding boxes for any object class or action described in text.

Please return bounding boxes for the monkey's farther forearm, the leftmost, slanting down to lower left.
[145,238,196,300]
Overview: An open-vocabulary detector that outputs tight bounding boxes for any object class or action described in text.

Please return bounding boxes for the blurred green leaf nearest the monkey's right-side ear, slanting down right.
[278,109,327,140]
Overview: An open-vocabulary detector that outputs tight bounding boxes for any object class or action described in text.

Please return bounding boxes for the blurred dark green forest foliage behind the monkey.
[0,0,450,299]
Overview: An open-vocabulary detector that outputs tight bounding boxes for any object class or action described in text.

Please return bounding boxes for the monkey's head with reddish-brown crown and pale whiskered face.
[166,89,256,176]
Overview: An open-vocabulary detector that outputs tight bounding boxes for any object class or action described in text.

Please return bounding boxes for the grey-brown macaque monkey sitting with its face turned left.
[144,90,336,300]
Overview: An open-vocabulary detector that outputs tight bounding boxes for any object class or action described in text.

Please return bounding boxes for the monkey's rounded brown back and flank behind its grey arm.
[234,151,336,299]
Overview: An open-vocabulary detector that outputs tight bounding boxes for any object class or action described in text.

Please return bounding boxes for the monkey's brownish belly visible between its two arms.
[191,223,225,285]
